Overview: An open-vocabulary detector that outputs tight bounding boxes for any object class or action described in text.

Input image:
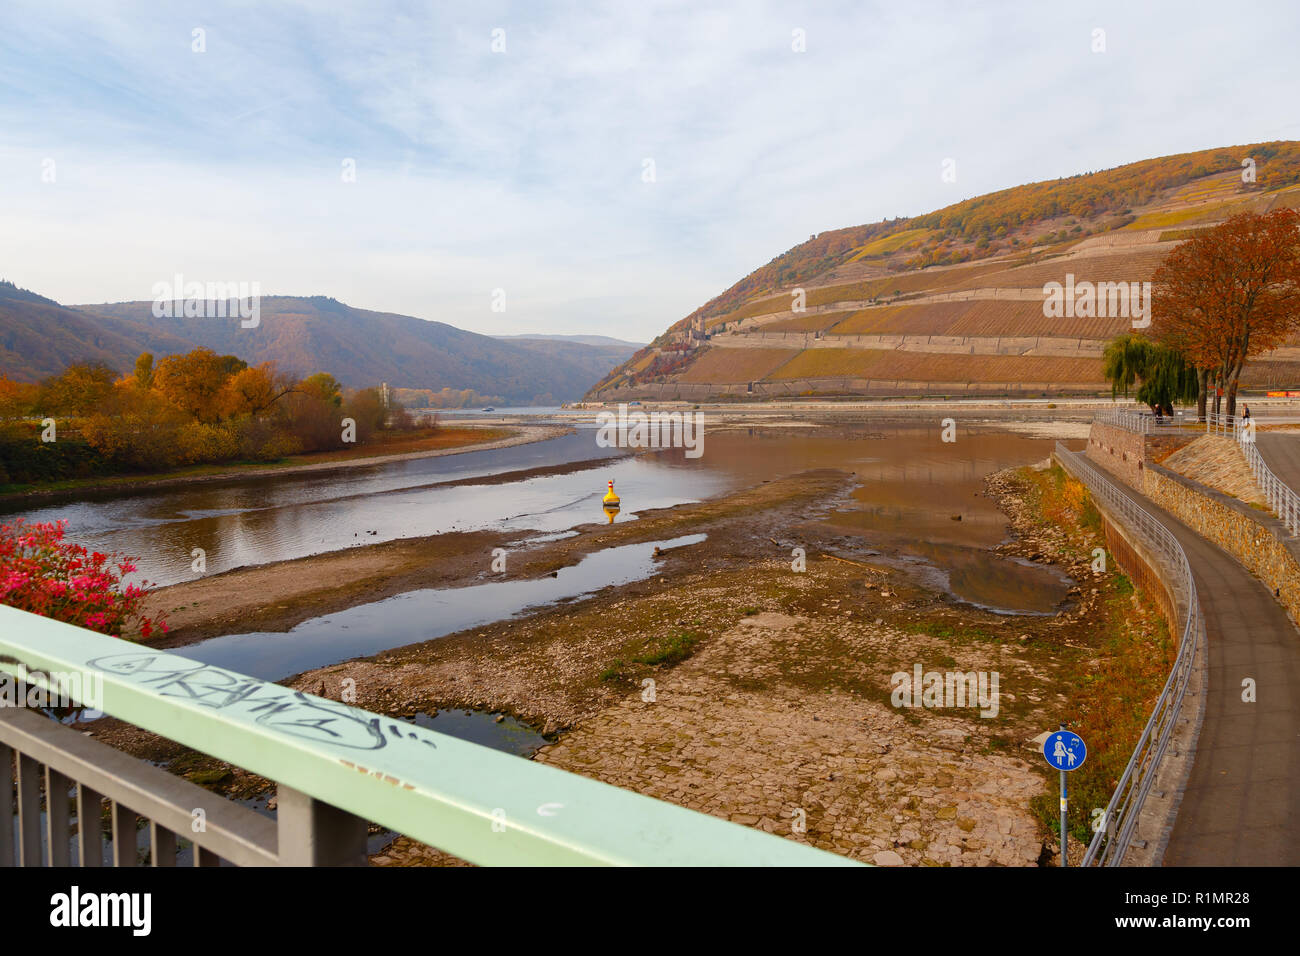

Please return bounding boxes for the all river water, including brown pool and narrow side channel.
[5,421,1070,679]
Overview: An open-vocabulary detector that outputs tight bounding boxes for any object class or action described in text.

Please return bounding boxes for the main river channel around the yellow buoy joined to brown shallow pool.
[10,424,1058,610]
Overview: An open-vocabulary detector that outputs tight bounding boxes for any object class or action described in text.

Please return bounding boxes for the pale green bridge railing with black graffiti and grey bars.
[0,605,854,866]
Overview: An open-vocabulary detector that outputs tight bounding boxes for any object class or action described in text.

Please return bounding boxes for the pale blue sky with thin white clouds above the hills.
[0,0,1300,341]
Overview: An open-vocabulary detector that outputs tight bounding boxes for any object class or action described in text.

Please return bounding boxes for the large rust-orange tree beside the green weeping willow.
[1152,208,1300,416]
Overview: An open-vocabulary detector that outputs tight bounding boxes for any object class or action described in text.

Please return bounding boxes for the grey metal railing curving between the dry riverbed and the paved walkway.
[1056,442,1205,866]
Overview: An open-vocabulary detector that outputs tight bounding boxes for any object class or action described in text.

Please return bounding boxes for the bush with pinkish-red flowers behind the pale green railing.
[0,518,168,639]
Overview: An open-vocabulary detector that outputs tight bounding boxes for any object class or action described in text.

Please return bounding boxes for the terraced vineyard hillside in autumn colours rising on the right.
[588,142,1300,401]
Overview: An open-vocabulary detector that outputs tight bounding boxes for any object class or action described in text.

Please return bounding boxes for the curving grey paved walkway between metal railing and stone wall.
[1092,449,1300,866]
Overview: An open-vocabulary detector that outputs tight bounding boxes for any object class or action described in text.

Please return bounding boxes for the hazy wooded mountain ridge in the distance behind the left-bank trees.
[0,282,637,403]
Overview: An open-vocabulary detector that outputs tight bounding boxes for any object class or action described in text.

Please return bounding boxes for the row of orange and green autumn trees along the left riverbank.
[0,347,413,484]
